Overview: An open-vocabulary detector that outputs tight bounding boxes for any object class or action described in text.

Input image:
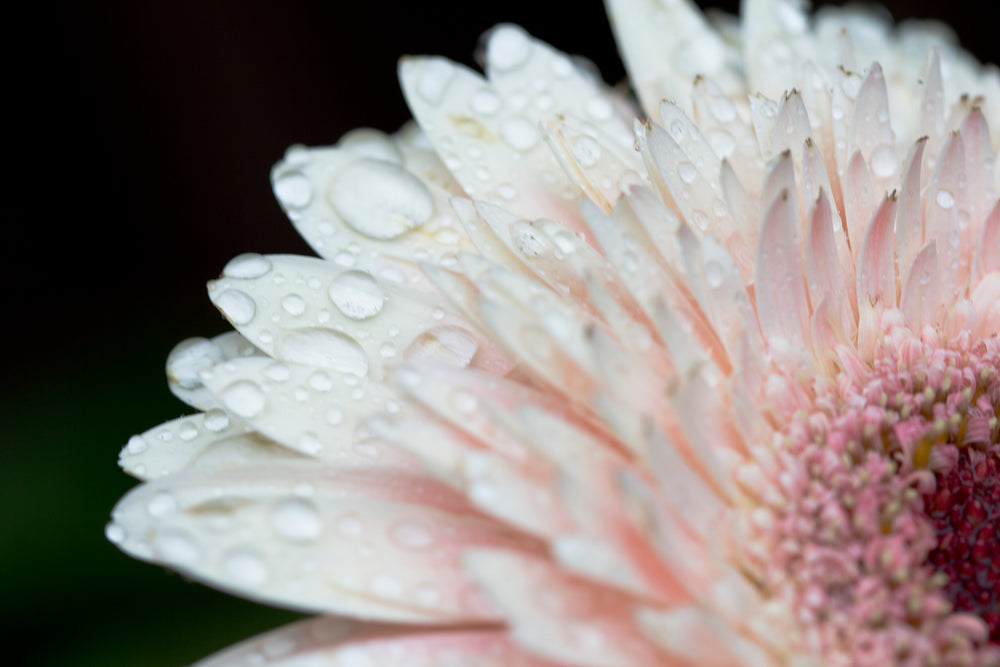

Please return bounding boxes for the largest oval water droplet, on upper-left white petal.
[328,160,434,240]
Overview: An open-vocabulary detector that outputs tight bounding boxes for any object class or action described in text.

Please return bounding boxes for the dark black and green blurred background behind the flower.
[0,0,998,666]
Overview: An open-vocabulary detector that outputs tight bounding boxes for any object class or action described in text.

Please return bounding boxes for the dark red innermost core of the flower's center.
[924,446,1000,644]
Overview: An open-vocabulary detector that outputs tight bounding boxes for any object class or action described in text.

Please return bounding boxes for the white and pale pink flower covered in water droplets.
[107,0,1000,667]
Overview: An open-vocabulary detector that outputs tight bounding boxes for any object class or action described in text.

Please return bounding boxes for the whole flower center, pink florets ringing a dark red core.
[744,329,1000,667]
